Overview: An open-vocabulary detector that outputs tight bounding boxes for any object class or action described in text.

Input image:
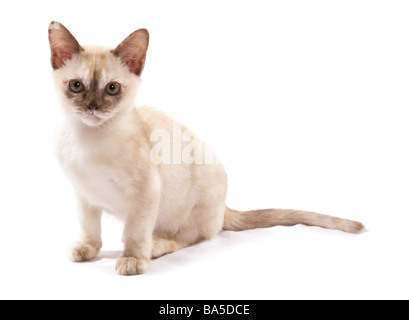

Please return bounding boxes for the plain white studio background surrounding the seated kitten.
[0,0,409,299]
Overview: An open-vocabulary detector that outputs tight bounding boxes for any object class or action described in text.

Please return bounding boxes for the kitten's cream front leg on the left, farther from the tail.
[69,196,102,262]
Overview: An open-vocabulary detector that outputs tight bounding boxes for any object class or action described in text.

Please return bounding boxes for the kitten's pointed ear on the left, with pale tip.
[48,21,83,70]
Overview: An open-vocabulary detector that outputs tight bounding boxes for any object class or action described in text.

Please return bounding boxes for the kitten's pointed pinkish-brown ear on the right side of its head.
[113,29,149,76]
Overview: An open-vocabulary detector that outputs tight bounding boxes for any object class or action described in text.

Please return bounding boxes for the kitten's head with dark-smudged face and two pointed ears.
[49,22,149,126]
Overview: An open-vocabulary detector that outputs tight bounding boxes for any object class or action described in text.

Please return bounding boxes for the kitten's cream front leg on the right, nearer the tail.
[116,172,160,275]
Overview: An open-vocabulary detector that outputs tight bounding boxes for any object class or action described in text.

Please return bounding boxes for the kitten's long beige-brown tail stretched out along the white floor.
[223,207,365,233]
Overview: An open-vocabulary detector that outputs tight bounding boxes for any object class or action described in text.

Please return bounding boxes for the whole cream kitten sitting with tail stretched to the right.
[49,22,364,275]
